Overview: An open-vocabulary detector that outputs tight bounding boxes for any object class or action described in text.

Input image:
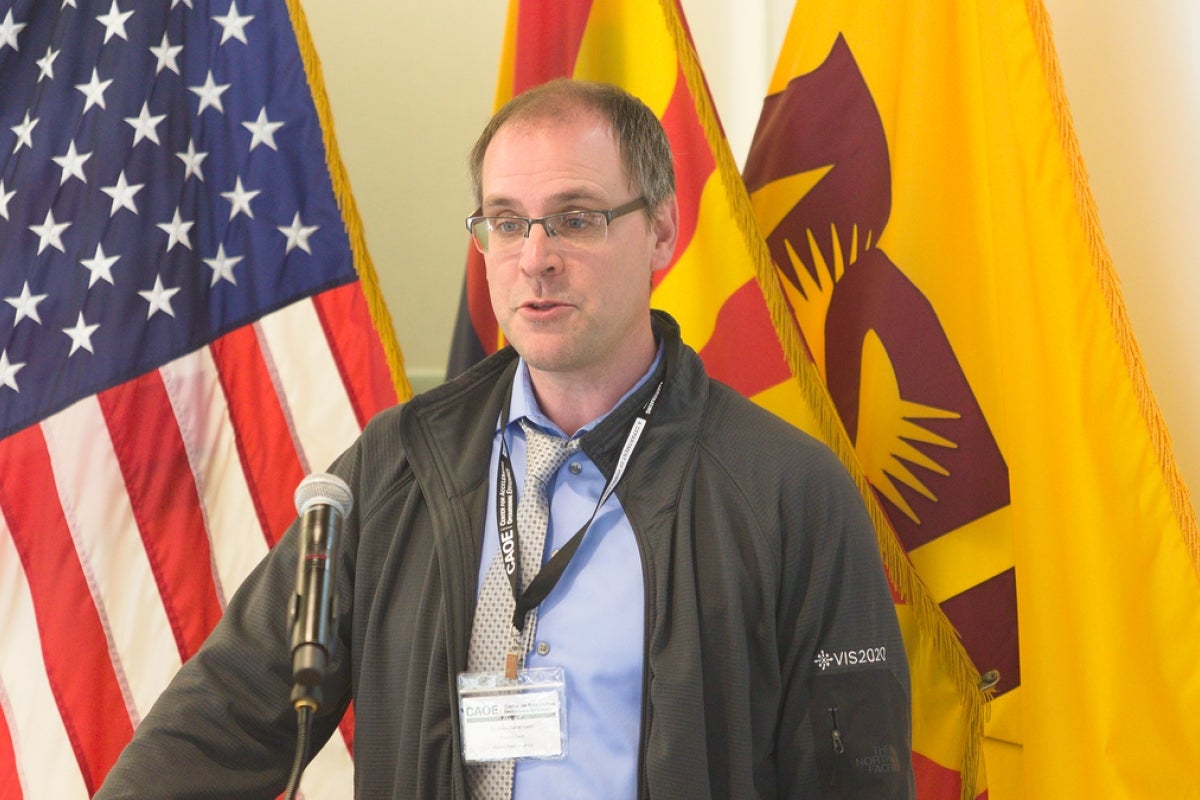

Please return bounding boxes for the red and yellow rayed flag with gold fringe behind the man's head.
[450,0,983,800]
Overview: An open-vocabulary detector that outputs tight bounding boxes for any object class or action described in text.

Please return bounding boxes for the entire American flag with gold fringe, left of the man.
[0,0,407,800]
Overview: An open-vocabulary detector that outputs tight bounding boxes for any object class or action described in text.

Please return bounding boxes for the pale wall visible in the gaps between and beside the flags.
[304,0,1200,506]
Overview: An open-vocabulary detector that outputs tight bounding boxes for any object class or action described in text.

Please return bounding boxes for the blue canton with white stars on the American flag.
[0,0,356,437]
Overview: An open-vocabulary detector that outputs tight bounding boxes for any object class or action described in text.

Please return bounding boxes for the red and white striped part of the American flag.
[0,284,395,800]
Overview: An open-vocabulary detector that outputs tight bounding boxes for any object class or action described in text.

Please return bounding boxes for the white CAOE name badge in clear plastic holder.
[458,667,566,763]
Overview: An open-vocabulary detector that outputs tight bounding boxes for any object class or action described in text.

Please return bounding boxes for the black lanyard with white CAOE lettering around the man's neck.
[496,380,662,662]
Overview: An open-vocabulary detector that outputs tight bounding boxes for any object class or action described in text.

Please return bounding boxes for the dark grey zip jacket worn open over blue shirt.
[97,312,912,800]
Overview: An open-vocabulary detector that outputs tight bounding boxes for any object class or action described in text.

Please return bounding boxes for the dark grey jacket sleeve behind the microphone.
[96,484,352,800]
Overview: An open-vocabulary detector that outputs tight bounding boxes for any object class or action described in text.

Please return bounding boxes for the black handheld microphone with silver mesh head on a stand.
[289,473,354,711]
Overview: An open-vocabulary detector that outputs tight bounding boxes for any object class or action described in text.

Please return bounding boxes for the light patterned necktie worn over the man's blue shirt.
[467,420,580,800]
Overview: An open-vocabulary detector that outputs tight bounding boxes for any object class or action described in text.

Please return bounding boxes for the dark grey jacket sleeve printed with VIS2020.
[776,447,916,800]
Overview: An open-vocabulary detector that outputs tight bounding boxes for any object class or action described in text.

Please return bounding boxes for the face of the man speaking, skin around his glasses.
[481,114,678,383]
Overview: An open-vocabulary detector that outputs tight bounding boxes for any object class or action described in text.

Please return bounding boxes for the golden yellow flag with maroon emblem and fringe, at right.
[745,0,1200,800]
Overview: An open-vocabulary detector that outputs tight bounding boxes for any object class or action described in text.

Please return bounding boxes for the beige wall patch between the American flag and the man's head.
[304,0,506,385]
